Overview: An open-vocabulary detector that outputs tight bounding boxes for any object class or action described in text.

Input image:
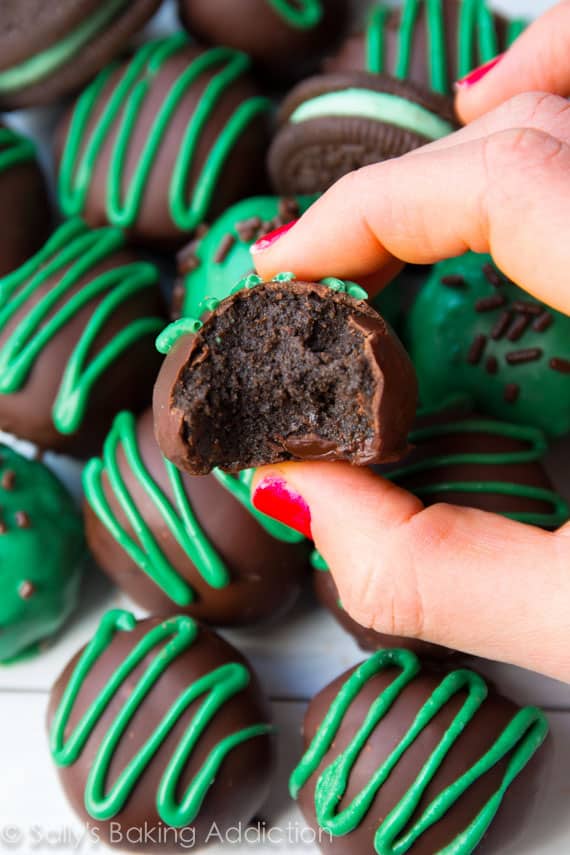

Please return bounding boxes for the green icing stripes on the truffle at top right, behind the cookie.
[365,0,526,95]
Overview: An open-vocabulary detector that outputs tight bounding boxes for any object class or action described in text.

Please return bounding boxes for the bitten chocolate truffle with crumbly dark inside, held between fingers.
[153,280,417,475]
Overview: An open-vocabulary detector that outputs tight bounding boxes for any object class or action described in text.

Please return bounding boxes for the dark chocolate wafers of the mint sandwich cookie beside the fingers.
[268,71,456,195]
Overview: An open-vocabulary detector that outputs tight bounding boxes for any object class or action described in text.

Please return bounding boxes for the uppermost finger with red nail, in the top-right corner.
[456,0,570,123]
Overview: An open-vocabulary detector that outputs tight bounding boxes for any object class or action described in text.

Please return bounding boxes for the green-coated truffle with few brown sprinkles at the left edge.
[0,445,85,664]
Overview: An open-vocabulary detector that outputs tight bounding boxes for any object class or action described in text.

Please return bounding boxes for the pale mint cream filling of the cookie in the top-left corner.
[0,0,129,93]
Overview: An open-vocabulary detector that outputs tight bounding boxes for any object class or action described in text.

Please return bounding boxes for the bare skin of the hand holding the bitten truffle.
[253,16,570,682]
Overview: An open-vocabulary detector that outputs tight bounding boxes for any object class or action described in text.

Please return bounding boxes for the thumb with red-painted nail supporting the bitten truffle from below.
[253,463,570,681]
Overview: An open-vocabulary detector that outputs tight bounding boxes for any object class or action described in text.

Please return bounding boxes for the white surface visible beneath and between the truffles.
[0,0,570,855]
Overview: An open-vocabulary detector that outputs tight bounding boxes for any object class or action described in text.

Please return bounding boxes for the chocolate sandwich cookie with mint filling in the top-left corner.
[0,0,160,110]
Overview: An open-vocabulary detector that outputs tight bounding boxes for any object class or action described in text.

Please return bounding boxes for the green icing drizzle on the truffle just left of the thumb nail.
[83,412,303,606]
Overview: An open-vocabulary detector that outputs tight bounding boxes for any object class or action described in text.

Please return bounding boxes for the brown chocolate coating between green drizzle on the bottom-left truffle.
[48,618,273,852]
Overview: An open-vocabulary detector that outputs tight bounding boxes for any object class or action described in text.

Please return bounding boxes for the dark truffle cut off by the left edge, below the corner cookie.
[0,125,52,276]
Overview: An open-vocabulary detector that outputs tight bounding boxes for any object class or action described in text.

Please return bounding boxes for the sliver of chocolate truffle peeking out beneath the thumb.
[313,570,454,659]
